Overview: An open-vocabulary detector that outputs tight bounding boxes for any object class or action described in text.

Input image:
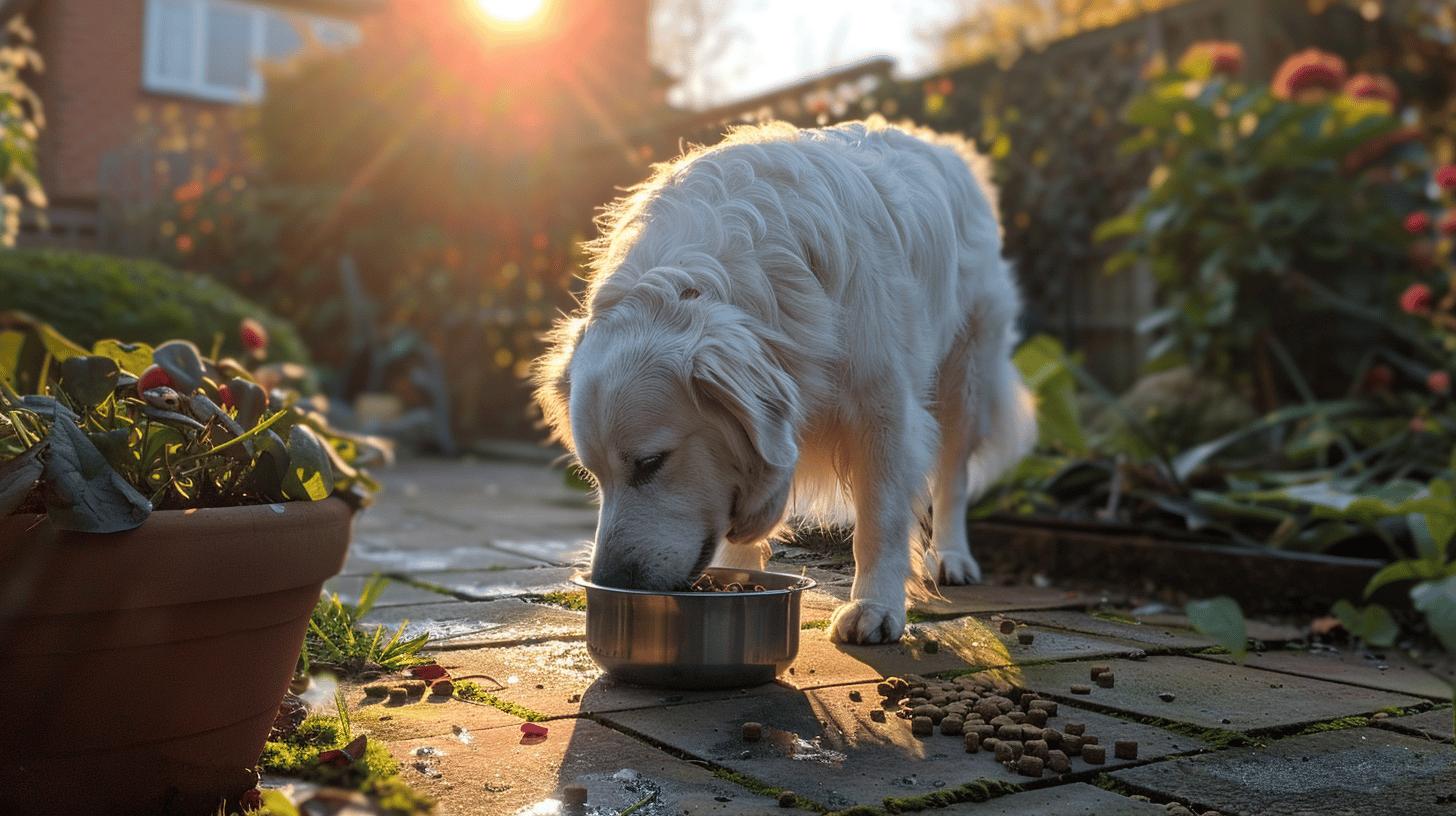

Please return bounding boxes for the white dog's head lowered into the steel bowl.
[536,287,799,590]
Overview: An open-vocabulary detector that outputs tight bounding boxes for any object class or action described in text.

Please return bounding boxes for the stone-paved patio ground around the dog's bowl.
[328,456,1456,816]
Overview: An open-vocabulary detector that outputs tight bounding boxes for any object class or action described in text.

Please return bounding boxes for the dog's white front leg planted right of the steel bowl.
[830,409,929,643]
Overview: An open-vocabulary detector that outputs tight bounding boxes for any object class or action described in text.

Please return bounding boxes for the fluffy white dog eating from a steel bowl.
[536,118,1035,643]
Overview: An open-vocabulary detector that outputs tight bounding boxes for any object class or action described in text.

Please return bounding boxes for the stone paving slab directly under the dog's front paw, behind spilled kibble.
[779,618,1143,689]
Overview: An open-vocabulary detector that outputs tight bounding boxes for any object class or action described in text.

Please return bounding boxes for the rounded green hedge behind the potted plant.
[0,249,309,363]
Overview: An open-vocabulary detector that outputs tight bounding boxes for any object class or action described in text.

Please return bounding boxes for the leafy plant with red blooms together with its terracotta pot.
[0,313,387,813]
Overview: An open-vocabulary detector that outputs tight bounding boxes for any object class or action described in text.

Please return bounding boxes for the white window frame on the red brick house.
[141,0,357,105]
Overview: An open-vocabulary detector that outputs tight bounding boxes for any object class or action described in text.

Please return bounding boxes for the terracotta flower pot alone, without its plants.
[0,498,352,813]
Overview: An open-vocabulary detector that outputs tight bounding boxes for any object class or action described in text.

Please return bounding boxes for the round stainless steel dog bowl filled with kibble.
[572,567,814,688]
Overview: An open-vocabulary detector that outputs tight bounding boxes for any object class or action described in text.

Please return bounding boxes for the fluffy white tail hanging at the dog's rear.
[965,335,1037,501]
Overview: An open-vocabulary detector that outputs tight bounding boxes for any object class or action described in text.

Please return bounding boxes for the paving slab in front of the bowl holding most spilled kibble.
[601,683,1204,807]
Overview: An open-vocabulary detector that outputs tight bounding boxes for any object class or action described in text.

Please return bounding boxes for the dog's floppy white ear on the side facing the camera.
[693,322,799,469]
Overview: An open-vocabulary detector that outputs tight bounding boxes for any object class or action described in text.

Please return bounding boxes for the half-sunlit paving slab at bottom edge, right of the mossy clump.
[389,705,804,816]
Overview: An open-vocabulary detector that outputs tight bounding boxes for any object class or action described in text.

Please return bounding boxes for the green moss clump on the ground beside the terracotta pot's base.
[258,710,435,815]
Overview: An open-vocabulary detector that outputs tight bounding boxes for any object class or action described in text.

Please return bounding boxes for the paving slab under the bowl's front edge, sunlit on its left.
[434,641,791,717]
